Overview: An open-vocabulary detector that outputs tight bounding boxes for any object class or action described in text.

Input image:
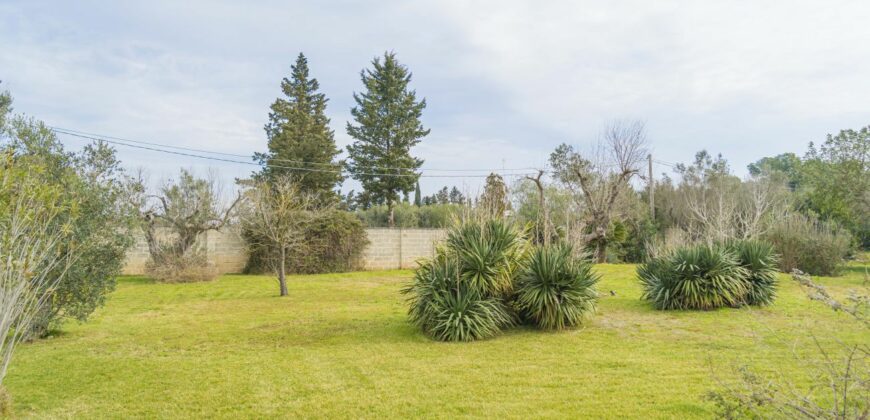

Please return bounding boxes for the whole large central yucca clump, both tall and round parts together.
[402,219,598,341]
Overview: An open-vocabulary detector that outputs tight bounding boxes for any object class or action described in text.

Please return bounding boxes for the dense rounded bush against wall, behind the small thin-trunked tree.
[242,210,369,274]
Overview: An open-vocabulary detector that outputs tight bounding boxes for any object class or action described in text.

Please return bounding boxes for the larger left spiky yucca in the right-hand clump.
[637,245,748,310]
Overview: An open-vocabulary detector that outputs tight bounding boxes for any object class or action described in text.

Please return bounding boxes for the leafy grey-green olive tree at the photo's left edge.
[0,85,136,336]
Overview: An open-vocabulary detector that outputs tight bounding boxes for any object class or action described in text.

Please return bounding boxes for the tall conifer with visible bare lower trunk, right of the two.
[347,52,429,226]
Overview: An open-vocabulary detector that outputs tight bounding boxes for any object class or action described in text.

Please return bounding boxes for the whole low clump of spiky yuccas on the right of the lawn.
[637,240,776,309]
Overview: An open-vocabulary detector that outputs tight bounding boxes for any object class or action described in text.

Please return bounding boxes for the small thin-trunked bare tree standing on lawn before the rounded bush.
[242,178,326,296]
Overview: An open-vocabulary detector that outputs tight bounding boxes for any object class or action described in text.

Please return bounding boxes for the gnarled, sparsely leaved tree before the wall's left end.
[142,169,241,281]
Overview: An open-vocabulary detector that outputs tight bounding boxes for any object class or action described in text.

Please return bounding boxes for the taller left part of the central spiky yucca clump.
[402,220,528,341]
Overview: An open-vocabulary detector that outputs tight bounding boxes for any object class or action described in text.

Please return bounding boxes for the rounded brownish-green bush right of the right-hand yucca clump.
[764,214,852,276]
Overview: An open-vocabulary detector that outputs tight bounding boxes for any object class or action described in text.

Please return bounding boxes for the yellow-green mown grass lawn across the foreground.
[6,265,868,418]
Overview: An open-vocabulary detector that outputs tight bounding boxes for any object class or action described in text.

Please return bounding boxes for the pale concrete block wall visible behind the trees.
[124,228,446,274]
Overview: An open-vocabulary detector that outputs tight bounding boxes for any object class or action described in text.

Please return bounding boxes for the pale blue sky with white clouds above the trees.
[0,0,870,194]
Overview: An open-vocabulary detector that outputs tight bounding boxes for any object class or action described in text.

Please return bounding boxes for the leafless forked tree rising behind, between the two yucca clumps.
[550,121,647,263]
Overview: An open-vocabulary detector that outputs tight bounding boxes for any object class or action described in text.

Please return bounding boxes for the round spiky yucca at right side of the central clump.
[515,245,598,330]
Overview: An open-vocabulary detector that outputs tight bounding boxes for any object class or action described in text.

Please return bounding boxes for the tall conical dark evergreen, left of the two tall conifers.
[254,53,343,195]
